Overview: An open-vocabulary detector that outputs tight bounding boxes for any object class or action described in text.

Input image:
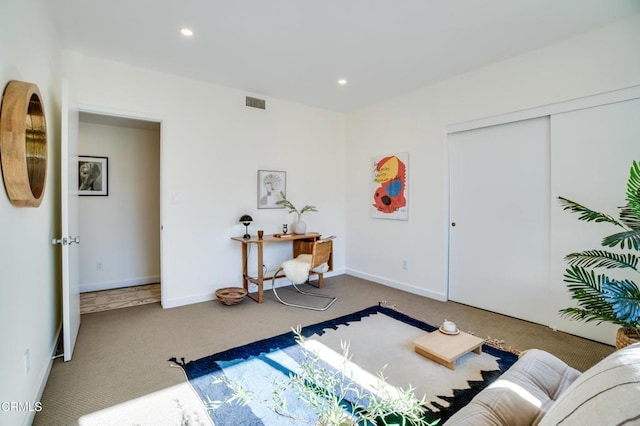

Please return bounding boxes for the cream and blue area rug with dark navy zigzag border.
[169,306,517,426]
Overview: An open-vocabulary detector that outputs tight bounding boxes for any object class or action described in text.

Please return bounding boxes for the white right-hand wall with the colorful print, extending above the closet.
[346,15,640,330]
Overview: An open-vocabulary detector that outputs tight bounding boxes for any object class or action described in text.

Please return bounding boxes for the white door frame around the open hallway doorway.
[77,104,167,307]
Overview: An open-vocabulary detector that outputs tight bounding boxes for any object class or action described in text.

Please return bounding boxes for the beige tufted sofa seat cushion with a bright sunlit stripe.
[445,349,580,426]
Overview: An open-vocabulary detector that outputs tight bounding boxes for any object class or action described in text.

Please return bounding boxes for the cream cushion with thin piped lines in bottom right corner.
[539,343,640,426]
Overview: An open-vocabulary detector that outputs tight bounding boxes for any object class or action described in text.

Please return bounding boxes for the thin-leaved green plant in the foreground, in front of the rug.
[209,327,439,426]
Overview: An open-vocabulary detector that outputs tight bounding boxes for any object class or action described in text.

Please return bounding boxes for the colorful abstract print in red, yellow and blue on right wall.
[371,152,409,220]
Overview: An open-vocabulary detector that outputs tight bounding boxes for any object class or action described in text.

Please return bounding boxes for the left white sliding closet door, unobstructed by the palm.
[448,117,550,324]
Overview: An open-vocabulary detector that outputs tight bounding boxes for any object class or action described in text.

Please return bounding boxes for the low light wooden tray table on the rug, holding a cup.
[413,330,484,370]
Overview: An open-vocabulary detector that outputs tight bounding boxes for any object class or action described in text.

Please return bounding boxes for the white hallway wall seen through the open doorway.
[78,120,160,292]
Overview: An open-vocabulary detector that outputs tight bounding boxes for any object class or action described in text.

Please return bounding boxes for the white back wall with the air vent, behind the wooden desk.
[63,52,347,307]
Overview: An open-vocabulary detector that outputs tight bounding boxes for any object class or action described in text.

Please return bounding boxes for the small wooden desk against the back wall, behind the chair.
[231,232,333,303]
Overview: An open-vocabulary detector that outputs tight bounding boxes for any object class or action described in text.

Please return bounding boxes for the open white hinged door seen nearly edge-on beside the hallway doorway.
[57,81,80,361]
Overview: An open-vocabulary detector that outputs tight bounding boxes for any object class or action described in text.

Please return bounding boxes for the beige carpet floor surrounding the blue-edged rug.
[34,275,614,425]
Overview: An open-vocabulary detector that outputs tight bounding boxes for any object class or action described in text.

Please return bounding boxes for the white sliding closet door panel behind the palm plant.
[549,99,640,344]
